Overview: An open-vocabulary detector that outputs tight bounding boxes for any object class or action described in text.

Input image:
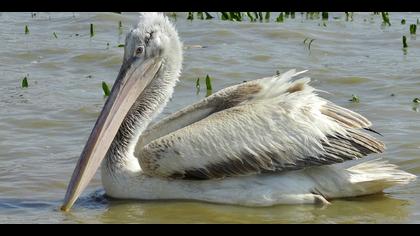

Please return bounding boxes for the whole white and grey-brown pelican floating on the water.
[61,13,416,211]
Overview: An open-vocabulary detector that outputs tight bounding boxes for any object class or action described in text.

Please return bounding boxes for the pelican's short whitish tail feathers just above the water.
[309,158,417,199]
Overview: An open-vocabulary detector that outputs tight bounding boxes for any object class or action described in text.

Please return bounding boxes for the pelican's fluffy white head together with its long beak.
[61,13,182,211]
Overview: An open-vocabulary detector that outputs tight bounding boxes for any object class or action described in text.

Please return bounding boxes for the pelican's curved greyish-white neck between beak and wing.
[104,60,181,172]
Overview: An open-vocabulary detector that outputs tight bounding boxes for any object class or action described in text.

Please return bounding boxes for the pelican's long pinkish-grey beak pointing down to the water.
[61,58,162,211]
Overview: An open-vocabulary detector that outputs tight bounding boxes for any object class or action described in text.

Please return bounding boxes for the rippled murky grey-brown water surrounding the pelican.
[0,13,420,223]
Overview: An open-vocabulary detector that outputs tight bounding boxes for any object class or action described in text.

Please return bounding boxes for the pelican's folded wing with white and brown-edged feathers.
[136,70,384,179]
